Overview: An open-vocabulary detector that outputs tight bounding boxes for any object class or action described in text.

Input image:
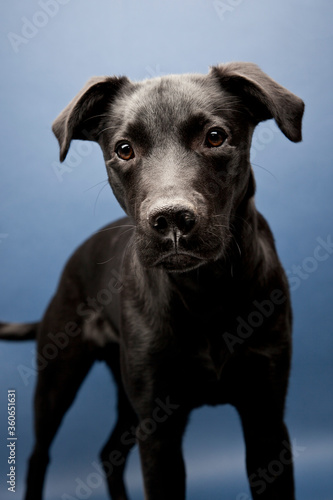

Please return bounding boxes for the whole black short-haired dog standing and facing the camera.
[1,63,304,500]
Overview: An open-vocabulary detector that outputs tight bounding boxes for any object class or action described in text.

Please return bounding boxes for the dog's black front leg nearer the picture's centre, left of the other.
[122,332,189,500]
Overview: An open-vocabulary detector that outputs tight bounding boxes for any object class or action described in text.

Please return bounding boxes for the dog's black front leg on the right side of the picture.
[238,356,295,500]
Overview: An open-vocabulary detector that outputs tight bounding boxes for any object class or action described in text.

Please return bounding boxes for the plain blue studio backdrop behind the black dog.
[0,0,333,500]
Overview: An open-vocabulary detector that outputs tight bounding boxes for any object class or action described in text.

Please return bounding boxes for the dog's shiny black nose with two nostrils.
[148,205,197,236]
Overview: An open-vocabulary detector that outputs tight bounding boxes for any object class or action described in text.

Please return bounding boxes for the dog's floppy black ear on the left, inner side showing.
[52,76,129,161]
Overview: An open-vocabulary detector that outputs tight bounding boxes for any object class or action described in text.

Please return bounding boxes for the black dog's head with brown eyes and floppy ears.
[53,63,304,271]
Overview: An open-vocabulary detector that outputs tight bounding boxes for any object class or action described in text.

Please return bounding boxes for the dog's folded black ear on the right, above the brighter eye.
[211,62,304,142]
